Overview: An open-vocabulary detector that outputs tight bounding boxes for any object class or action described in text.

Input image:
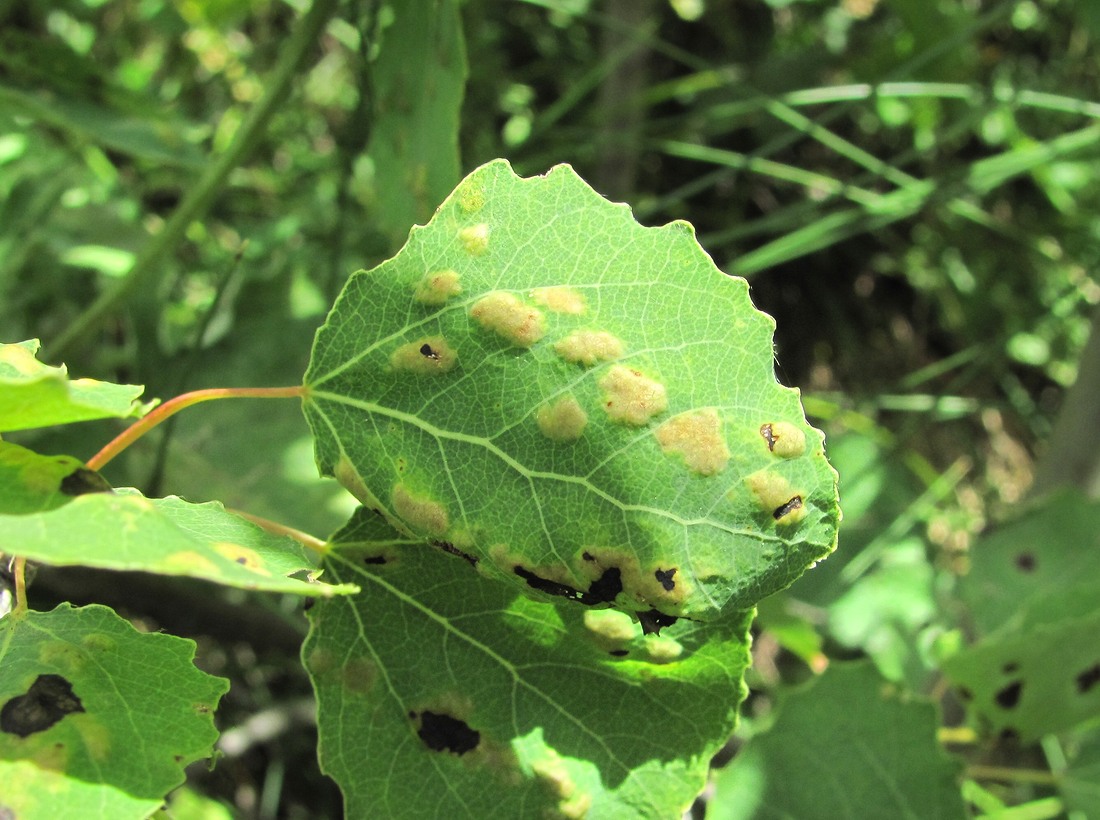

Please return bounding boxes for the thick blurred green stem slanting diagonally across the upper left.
[50,0,337,360]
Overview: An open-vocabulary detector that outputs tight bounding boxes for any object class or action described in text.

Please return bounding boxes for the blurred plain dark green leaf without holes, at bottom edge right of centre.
[706,663,966,820]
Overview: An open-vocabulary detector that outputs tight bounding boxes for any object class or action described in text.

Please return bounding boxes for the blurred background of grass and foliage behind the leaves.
[0,0,1100,817]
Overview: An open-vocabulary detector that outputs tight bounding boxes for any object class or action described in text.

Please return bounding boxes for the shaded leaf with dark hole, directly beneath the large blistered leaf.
[303,511,751,818]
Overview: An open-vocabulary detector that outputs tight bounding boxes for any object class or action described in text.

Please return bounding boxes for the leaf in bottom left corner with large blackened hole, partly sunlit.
[0,604,229,820]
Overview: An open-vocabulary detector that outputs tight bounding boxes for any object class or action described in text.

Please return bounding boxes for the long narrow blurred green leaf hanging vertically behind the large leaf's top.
[367,0,466,241]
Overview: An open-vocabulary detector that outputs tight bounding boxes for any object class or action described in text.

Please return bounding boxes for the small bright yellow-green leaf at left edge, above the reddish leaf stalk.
[0,339,145,433]
